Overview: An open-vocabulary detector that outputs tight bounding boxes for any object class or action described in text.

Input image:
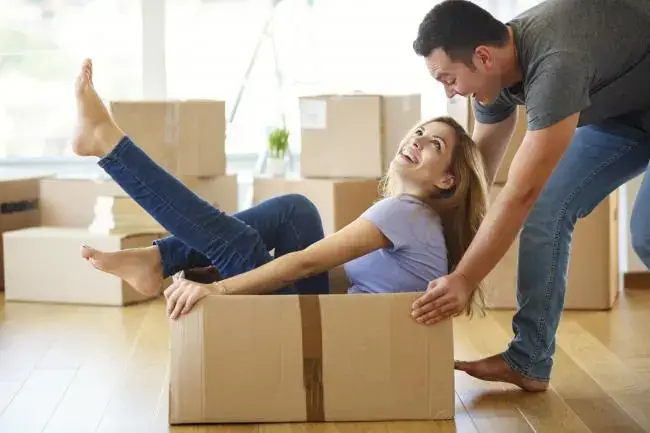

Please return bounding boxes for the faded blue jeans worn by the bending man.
[503,113,650,380]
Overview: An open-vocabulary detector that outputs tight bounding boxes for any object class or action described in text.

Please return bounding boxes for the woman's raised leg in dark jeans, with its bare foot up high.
[74,57,288,294]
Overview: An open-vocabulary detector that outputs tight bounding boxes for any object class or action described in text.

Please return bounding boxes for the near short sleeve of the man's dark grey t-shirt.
[526,52,593,131]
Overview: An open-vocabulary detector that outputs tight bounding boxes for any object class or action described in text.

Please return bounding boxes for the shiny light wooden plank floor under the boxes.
[0,290,650,433]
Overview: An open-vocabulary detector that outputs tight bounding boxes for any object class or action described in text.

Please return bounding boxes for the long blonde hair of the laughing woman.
[381,116,489,316]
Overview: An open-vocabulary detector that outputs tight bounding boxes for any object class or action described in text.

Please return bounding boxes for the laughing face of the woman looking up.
[391,121,458,194]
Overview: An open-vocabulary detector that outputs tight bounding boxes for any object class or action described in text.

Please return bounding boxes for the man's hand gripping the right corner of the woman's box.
[411,273,472,325]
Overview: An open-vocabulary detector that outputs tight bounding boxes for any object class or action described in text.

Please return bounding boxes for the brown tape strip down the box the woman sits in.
[298,295,325,422]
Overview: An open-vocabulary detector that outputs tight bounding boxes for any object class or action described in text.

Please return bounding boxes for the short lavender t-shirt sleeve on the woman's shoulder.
[361,196,419,250]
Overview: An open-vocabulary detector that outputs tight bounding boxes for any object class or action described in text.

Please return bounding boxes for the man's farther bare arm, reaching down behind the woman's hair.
[472,111,517,185]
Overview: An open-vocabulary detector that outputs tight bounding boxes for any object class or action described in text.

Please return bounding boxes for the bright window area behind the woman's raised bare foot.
[0,0,142,157]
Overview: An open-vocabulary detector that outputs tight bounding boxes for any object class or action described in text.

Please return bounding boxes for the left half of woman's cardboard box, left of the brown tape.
[169,296,306,423]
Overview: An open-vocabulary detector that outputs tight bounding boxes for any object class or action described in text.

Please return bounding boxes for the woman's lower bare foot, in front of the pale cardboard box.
[81,245,163,296]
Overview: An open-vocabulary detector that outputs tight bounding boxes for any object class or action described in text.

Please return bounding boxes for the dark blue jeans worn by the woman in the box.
[98,137,329,294]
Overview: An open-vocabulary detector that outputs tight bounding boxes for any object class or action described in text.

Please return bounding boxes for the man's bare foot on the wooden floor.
[454,355,548,392]
